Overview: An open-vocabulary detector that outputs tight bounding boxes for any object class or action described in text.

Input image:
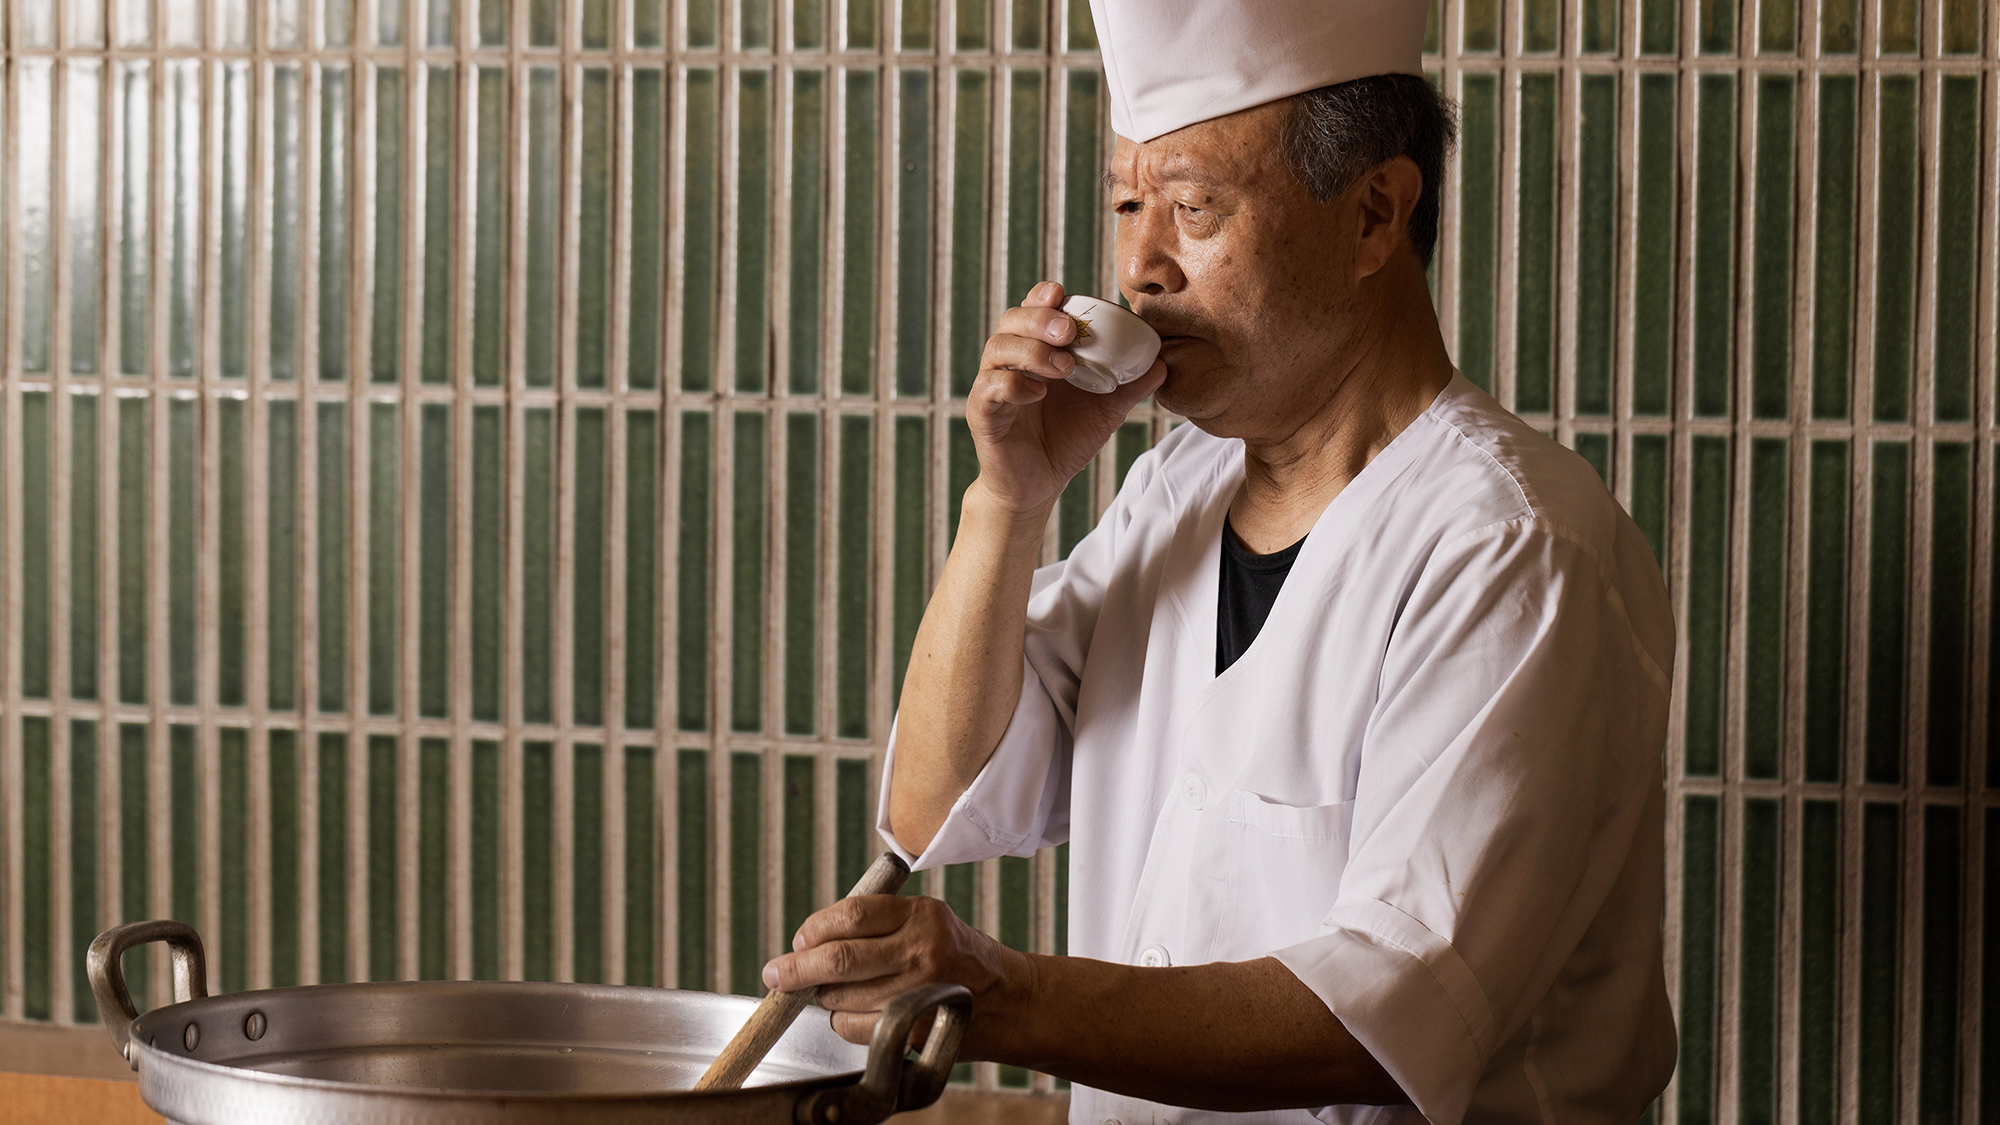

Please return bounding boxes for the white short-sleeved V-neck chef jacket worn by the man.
[880,376,1674,1125]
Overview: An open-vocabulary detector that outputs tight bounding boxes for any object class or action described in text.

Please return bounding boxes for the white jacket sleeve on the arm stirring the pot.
[1276,518,1672,1125]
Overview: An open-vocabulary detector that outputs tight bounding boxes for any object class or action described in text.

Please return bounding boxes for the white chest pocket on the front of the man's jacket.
[1216,789,1354,961]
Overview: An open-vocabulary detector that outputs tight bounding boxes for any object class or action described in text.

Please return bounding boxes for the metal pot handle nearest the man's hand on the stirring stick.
[794,985,972,1125]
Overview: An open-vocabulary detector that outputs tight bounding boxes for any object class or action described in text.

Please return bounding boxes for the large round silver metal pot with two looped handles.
[88,921,972,1125]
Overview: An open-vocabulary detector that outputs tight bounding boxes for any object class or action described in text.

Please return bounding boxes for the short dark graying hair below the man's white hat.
[1284,74,1458,266]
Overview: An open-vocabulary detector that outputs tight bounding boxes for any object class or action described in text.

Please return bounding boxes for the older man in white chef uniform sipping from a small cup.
[764,0,1674,1125]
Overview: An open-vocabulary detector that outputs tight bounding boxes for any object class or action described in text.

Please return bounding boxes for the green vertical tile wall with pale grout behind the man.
[0,0,2000,1104]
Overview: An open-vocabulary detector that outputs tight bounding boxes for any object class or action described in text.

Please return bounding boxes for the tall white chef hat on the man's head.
[1090,0,1426,142]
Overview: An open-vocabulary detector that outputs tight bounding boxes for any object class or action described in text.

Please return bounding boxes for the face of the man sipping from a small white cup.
[1106,102,1358,438]
